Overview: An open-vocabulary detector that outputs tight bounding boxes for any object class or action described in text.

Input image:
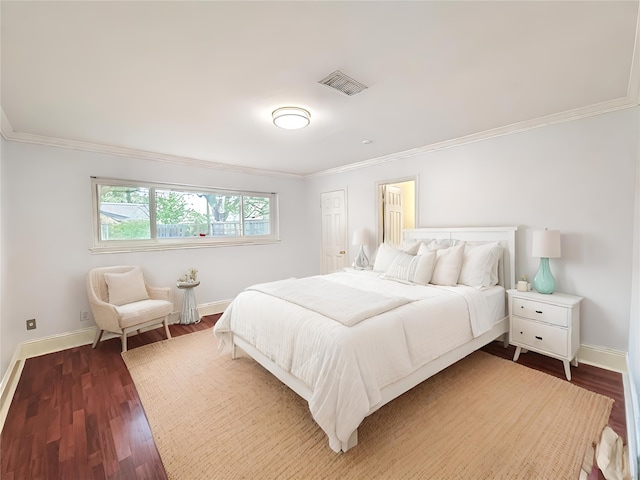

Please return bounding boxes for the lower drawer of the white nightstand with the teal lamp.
[509,317,569,357]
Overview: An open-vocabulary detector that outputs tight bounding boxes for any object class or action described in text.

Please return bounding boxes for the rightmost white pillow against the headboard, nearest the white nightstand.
[458,242,502,288]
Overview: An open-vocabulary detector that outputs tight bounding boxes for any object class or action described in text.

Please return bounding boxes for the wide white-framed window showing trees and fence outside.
[91,178,279,252]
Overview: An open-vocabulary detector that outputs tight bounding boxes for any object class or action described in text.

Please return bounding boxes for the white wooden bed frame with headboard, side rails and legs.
[231,227,517,452]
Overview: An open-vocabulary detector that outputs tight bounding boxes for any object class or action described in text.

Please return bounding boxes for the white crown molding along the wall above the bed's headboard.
[304,96,638,180]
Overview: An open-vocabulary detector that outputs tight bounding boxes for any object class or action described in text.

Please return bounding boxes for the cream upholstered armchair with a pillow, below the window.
[87,266,173,352]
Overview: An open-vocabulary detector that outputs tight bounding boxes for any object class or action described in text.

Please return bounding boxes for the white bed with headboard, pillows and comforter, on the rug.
[214,227,517,452]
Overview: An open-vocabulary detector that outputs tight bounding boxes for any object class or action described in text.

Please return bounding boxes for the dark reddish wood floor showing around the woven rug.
[0,316,626,480]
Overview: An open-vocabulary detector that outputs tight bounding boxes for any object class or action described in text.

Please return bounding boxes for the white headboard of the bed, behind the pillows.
[404,227,518,289]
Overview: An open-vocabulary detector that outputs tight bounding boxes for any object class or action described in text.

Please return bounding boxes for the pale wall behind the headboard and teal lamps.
[306,108,638,351]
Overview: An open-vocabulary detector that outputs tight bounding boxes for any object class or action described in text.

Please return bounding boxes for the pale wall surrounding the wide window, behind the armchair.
[0,141,318,377]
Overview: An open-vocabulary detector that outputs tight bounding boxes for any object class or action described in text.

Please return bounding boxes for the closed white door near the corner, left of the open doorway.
[320,190,347,274]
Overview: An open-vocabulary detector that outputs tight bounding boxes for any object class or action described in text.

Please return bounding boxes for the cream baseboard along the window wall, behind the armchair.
[0,300,231,429]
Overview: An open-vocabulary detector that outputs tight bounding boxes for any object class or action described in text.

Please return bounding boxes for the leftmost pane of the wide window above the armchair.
[98,185,151,240]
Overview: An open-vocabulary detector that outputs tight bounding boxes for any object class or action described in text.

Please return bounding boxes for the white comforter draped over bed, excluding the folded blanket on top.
[214,272,492,452]
